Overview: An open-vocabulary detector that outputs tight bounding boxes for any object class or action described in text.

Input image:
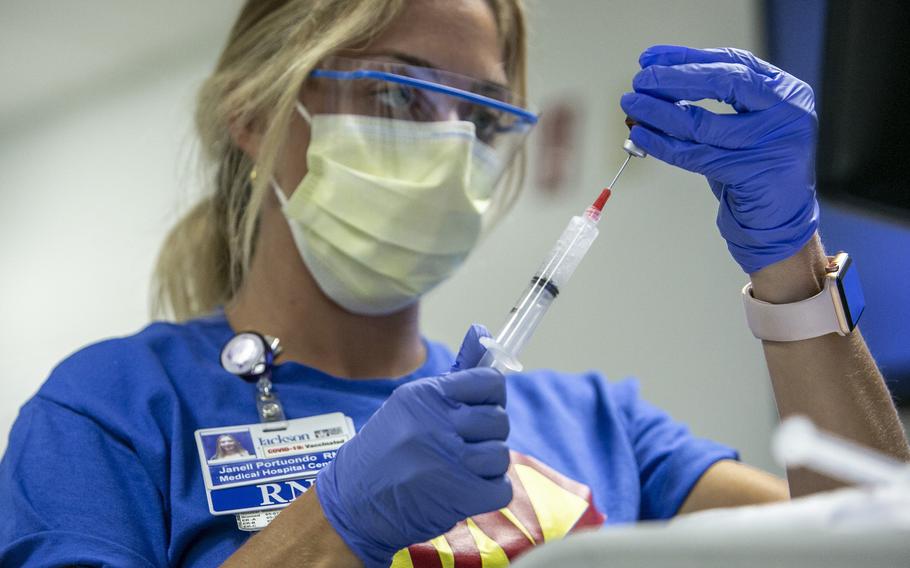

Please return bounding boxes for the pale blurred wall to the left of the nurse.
[0,0,239,452]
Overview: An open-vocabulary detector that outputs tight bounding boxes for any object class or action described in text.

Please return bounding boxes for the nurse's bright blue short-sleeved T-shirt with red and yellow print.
[0,314,736,566]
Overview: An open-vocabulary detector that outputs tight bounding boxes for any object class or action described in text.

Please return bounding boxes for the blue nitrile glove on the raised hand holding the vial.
[621,45,818,273]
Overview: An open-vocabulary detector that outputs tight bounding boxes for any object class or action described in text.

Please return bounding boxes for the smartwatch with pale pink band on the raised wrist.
[743,252,866,341]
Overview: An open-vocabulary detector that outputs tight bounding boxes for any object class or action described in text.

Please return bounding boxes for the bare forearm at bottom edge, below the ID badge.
[224,486,363,568]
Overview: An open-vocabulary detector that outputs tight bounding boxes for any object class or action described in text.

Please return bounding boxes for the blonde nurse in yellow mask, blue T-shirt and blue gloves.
[0,0,908,567]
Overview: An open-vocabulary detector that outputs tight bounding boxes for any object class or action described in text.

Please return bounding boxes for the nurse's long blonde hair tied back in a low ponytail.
[152,0,526,320]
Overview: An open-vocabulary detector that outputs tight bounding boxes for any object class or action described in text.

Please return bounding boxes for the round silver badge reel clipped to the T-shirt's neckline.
[221,331,287,531]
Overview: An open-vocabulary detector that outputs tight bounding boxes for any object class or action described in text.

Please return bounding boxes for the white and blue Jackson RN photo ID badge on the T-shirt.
[196,412,355,518]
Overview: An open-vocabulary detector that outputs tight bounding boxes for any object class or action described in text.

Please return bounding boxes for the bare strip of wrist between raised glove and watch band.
[749,233,828,304]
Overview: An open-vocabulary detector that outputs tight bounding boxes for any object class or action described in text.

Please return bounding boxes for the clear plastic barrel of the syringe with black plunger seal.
[488,215,598,359]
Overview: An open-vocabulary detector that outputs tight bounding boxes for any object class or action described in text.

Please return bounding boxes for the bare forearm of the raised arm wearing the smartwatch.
[752,235,910,497]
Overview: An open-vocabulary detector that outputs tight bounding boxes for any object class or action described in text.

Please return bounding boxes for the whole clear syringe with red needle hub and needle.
[477,141,647,373]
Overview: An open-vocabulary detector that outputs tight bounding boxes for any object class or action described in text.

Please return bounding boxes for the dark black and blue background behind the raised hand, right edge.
[765,0,910,400]
